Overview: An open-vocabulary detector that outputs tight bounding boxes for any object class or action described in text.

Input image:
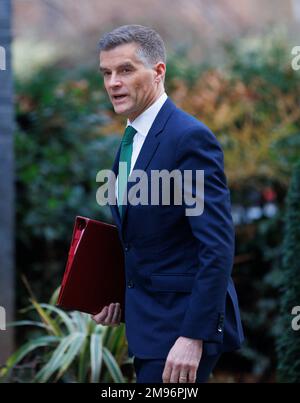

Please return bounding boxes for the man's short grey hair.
[98,25,167,66]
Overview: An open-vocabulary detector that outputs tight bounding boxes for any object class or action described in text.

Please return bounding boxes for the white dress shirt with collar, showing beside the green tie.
[115,92,168,204]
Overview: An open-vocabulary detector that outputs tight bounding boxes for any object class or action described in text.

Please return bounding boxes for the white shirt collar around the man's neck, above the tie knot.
[127,92,168,137]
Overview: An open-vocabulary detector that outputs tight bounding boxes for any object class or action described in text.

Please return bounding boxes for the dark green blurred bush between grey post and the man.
[15,68,120,305]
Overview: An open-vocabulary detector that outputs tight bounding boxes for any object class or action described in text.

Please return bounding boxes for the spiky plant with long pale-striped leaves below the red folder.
[0,292,130,383]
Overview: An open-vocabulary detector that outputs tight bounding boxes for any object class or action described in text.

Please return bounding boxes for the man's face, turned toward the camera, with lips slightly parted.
[100,43,165,121]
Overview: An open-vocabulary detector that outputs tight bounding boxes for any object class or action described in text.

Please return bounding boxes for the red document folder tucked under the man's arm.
[57,216,125,322]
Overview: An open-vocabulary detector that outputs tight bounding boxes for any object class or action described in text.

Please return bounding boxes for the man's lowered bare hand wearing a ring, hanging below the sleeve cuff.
[162,336,203,383]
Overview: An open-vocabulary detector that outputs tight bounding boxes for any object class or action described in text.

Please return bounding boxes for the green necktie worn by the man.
[118,126,137,218]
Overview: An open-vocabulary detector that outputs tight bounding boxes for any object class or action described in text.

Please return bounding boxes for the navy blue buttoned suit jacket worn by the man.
[111,98,243,358]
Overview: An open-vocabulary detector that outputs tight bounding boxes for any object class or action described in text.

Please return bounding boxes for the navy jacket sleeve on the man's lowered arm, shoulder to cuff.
[176,125,234,343]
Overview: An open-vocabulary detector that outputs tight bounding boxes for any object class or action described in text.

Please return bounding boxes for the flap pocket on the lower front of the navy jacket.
[151,273,195,293]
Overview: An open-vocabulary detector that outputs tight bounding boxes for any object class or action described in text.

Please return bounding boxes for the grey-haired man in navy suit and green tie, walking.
[93,25,243,383]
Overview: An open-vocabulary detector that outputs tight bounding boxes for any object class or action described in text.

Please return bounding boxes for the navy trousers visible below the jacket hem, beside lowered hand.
[133,354,221,383]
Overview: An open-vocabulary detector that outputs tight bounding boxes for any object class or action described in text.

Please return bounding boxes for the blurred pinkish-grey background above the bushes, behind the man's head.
[13,0,300,71]
